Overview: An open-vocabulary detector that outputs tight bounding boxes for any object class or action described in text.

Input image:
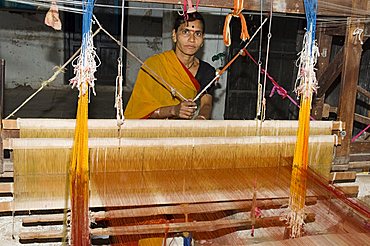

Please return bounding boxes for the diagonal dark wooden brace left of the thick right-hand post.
[317,47,344,97]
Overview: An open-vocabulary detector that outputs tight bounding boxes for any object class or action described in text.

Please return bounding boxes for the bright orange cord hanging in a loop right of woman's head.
[223,0,249,46]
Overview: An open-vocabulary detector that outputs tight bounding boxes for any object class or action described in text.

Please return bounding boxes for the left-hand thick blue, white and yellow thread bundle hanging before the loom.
[69,0,97,246]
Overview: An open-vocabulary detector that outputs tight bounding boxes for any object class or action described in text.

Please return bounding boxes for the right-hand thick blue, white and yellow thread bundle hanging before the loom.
[287,0,318,238]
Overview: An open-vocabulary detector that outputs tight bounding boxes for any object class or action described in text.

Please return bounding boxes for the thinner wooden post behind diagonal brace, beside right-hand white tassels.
[312,27,333,120]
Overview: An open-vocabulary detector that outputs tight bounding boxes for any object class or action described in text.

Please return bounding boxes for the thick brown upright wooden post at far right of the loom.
[335,16,367,165]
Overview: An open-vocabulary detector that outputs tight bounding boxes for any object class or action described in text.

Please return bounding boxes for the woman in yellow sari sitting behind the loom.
[125,12,215,120]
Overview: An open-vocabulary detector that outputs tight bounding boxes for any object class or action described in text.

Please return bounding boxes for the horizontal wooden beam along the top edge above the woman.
[129,0,364,16]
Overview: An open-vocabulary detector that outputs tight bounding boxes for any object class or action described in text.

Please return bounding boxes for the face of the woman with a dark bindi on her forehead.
[172,20,204,56]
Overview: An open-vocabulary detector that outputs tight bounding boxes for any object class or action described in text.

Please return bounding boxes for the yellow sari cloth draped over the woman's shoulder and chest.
[125,50,200,119]
